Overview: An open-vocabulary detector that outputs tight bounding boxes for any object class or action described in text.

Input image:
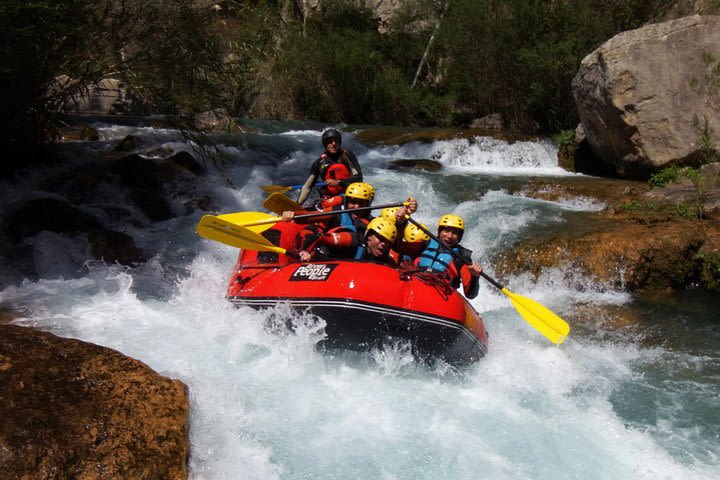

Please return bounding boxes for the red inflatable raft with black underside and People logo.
[227,223,488,365]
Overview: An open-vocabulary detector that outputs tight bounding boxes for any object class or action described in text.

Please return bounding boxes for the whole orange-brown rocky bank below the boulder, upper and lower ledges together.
[492,169,720,293]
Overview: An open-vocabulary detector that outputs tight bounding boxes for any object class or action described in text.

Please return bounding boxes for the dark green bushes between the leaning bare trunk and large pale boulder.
[430,0,668,131]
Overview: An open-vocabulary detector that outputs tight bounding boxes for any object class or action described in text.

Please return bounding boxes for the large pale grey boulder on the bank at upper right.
[572,15,720,178]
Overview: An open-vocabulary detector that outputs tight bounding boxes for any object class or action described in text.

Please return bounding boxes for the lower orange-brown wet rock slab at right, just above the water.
[493,212,720,291]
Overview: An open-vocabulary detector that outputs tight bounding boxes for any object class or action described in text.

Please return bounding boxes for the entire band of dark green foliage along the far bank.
[0,0,688,141]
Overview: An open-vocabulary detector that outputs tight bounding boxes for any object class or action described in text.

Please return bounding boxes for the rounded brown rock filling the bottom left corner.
[0,325,189,479]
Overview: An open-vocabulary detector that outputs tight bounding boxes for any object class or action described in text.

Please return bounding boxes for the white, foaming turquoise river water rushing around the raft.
[0,122,720,480]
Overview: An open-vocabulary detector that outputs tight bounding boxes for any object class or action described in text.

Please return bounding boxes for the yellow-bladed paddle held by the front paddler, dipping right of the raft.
[405,215,570,345]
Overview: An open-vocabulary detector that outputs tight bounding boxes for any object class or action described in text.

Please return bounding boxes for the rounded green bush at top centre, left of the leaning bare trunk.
[276,1,448,124]
